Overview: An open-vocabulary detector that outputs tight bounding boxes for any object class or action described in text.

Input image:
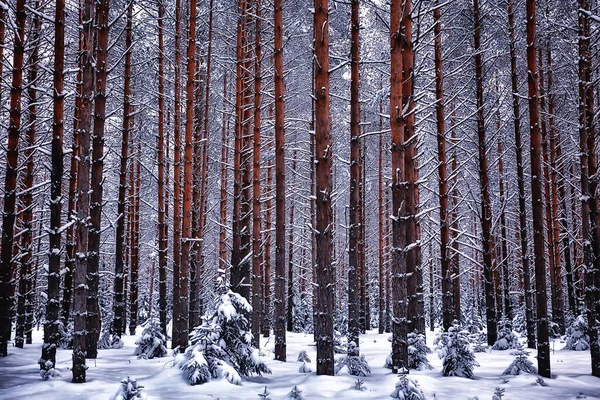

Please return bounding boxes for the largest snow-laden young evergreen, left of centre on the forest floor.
[176,291,271,385]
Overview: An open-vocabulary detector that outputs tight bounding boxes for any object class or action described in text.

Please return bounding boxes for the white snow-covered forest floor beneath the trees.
[0,329,600,400]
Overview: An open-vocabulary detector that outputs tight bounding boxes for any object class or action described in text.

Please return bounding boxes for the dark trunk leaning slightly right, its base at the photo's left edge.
[0,0,26,357]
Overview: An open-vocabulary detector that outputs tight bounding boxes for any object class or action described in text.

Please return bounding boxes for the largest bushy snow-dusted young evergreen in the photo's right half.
[436,321,479,379]
